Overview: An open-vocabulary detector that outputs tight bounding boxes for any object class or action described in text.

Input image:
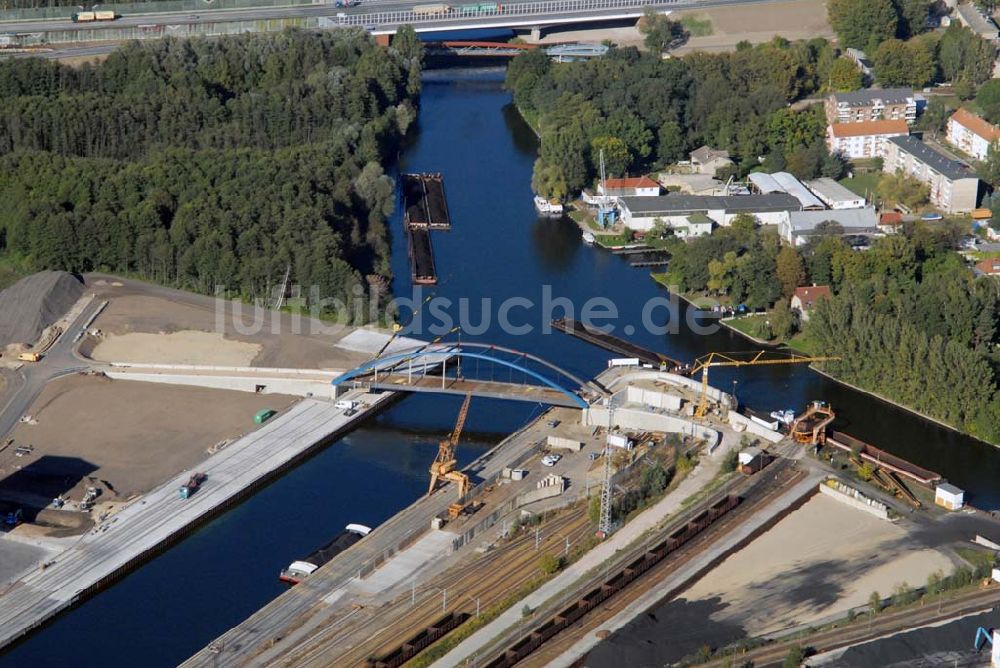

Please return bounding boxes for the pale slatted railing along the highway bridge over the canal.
[332,0,676,27]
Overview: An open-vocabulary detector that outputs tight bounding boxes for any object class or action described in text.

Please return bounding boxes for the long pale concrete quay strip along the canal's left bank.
[0,393,395,647]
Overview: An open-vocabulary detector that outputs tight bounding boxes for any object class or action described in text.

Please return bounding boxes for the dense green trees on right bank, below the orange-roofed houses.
[654,214,1000,443]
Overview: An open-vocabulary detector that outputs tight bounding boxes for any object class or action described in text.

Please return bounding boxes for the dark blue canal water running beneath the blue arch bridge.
[0,69,1000,666]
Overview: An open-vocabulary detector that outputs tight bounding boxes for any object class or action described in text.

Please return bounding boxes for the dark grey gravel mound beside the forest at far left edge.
[0,271,83,348]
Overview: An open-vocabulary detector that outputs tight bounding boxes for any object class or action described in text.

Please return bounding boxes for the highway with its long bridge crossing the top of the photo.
[0,0,684,47]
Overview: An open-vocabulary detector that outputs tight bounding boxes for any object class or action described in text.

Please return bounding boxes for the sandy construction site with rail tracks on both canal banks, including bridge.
[0,268,1000,668]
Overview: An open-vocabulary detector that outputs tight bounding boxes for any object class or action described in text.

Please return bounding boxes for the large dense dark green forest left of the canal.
[0,30,423,316]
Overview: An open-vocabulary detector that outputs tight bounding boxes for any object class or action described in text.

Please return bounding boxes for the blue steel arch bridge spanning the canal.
[332,343,607,409]
